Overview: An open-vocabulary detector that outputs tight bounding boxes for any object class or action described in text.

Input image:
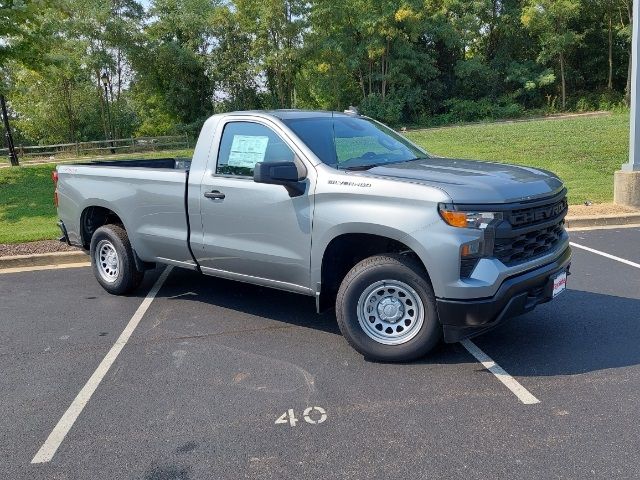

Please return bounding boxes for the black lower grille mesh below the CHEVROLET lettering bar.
[493,220,564,266]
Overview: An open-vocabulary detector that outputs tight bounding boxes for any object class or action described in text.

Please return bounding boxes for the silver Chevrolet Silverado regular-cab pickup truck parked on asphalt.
[54,110,571,361]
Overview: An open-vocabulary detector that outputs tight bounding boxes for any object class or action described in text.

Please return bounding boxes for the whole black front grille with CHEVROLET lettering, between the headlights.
[493,191,567,267]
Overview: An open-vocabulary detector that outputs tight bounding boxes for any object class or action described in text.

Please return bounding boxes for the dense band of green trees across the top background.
[0,0,632,142]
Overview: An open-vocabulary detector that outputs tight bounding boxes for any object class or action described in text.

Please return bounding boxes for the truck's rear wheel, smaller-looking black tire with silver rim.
[90,225,144,295]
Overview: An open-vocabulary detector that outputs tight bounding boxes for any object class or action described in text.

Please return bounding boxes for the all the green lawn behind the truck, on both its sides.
[0,113,629,243]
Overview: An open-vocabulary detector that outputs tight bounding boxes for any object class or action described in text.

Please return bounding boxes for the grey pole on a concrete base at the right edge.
[613,0,640,207]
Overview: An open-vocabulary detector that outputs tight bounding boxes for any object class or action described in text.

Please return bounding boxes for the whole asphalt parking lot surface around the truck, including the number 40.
[0,228,640,479]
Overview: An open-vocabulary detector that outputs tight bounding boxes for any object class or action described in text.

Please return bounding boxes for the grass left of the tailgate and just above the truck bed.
[0,150,192,243]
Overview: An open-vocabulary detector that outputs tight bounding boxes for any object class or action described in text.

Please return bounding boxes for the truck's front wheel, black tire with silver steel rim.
[336,254,442,362]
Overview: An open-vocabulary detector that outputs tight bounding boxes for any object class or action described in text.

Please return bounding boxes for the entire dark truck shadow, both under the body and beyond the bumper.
[149,269,640,376]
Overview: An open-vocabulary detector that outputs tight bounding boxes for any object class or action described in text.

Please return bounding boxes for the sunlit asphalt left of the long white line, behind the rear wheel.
[0,268,161,478]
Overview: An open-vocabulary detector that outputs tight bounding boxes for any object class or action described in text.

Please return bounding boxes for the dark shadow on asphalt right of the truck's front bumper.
[464,290,640,376]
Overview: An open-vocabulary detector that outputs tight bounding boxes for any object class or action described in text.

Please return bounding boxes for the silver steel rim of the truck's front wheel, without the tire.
[358,280,424,345]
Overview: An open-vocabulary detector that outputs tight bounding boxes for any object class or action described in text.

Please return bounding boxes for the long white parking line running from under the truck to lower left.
[31,266,173,463]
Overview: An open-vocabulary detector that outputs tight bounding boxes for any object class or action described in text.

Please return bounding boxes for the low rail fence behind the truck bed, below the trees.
[0,134,189,164]
